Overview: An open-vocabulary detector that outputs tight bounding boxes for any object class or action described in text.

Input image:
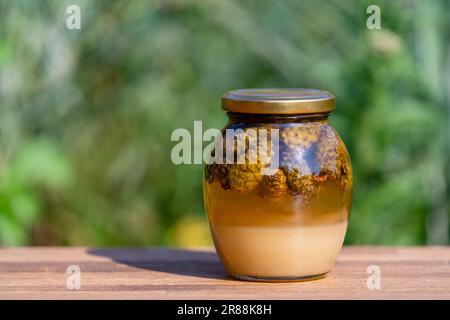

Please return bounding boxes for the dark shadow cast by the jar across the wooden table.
[88,248,229,279]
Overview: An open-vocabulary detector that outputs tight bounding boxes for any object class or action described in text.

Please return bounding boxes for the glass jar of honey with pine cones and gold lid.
[203,89,352,281]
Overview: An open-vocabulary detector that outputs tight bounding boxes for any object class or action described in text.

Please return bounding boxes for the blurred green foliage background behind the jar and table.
[0,0,450,246]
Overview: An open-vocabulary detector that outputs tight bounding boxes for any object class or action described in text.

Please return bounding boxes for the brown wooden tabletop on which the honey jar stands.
[0,247,450,299]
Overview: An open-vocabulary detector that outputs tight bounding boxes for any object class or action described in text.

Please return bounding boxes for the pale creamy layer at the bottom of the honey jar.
[212,221,347,277]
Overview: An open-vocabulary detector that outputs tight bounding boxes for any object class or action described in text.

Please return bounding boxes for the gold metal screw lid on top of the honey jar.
[222,88,335,114]
